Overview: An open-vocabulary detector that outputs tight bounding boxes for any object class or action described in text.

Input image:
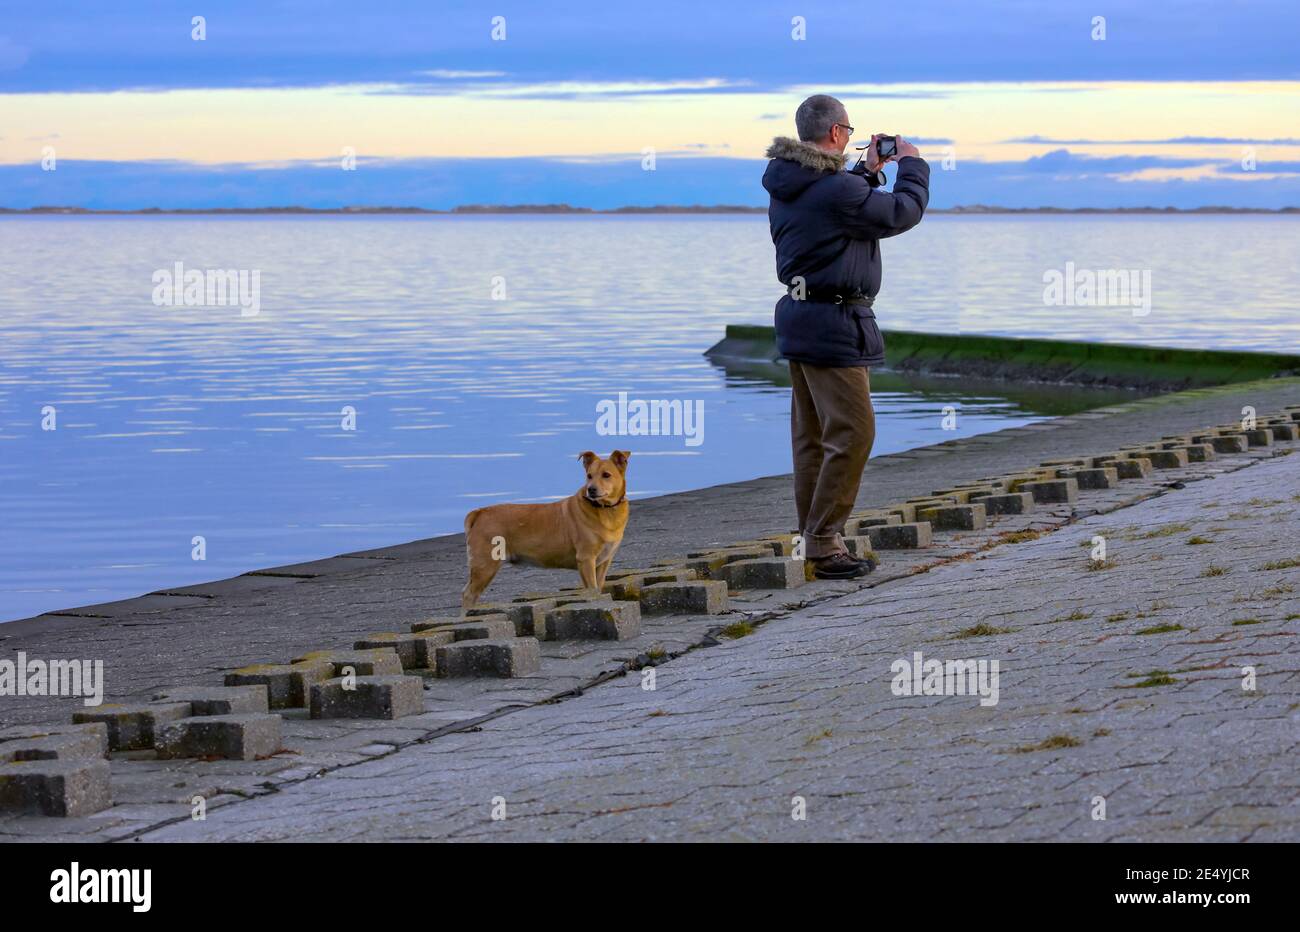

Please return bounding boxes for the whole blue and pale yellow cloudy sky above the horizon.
[0,0,1300,209]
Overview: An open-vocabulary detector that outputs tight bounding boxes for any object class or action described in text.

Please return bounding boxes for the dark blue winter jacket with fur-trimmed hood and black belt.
[763,136,930,367]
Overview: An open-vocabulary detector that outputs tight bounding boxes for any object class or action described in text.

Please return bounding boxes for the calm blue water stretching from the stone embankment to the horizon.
[0,216,1300,619]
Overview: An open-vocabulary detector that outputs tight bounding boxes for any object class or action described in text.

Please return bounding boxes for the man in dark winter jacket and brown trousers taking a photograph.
[763,94,930,580]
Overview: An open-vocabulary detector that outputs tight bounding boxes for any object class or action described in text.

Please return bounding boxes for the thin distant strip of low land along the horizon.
[0,204,1300,217]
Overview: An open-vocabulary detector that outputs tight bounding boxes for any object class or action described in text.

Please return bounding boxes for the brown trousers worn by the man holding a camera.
[790,360,876,559]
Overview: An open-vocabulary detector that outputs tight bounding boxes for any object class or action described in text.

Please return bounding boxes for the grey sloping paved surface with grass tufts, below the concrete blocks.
[134,432,1300,841]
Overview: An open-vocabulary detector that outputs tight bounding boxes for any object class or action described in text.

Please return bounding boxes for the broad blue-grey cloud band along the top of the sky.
[0,0,1300,92]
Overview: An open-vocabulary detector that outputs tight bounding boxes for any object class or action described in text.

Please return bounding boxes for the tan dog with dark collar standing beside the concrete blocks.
[460,450,632,608]
